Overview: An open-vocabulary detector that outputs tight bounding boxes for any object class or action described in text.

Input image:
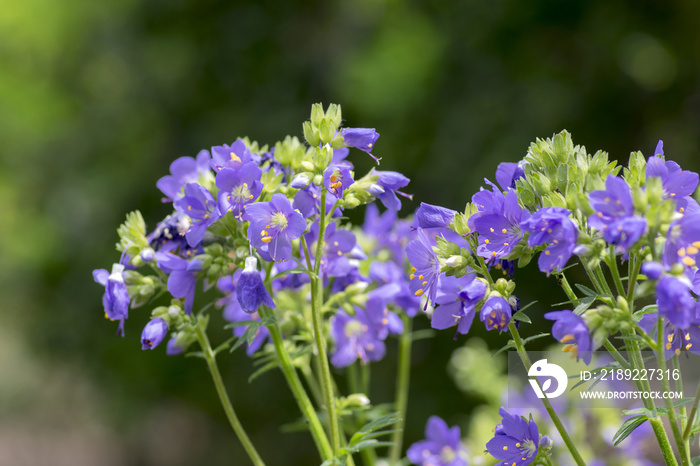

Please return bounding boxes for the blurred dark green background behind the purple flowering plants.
[0,0,700,466]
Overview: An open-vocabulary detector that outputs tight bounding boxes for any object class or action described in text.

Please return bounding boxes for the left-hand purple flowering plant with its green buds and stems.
[94,104,432,465]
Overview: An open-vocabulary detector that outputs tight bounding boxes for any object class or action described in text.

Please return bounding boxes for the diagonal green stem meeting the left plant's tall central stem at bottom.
[260,306,334,460]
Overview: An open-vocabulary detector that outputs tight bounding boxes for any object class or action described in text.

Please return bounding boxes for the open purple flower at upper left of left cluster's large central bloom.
[216,162,263,218]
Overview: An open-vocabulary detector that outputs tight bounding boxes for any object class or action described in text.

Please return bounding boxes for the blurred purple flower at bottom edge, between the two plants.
[406,416,468,466]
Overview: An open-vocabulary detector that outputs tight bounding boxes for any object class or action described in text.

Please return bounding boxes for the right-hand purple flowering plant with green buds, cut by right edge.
[406,131,700,466]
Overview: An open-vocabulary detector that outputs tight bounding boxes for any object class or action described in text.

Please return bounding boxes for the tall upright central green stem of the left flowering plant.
[311,189,340,456]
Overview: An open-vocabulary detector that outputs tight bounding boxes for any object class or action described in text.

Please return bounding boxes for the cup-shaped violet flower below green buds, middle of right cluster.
[520,207,578,274]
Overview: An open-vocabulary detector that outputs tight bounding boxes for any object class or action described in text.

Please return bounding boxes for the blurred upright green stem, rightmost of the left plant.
[389,313,413,464]
